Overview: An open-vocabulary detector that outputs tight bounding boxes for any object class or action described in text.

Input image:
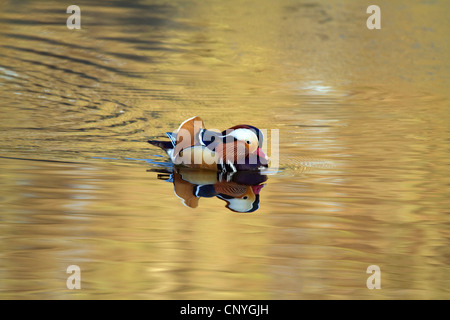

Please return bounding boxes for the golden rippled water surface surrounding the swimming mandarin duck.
[0,0,450,299]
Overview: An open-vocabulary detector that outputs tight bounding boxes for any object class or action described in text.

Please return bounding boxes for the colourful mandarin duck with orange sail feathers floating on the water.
[148,116,270,172]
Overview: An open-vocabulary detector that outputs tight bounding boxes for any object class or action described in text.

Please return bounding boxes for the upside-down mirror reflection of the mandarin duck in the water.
[149,167,268,212]
